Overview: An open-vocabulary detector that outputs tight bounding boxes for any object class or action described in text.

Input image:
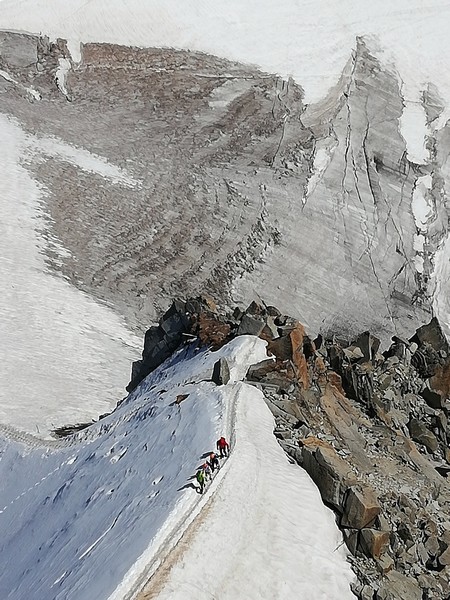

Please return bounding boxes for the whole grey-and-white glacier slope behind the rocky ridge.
[0,0,450,433]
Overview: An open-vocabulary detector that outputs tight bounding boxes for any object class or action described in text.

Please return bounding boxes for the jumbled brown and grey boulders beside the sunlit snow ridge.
[159,299,450,600]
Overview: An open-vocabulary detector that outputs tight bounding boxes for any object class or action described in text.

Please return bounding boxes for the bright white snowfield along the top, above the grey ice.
[0,0,450,111]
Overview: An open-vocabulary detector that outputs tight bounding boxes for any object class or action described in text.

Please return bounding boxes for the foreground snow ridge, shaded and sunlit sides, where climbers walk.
[0,336,351,600]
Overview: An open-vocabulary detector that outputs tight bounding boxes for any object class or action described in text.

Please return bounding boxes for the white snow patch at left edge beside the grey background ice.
[0,115,141,436]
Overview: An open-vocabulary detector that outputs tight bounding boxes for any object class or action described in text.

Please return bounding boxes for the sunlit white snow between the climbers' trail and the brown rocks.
[137,384,354,600]
